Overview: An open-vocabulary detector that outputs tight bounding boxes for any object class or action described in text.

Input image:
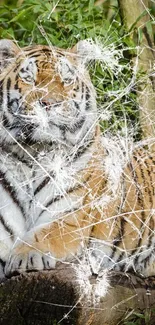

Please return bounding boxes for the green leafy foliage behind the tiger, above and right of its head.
[0,0,154,138]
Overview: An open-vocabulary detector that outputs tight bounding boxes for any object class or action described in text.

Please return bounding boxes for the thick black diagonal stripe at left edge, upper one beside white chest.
[0,171,25,218]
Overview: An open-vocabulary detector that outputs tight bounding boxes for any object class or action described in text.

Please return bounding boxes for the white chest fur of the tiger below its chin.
[0,141,92,232]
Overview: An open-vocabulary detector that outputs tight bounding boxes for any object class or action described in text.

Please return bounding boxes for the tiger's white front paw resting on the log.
[5,249,56,277]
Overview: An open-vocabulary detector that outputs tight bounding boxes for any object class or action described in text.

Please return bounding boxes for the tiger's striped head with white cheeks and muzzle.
[0,40,96,144]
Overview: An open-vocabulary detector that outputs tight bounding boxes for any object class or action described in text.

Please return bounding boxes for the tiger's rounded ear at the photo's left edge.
[0,39,19,73]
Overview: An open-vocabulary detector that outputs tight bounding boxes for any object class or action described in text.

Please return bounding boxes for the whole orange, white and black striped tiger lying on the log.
[0,40,155,281]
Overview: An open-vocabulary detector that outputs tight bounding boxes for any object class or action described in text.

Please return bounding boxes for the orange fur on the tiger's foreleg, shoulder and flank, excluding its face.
[12,135,155,275]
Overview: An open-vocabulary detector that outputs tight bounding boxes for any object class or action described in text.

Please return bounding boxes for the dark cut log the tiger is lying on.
[0,263,155,325]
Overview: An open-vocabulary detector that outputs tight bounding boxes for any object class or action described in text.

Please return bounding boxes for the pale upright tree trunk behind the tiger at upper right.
[118,0,155,143]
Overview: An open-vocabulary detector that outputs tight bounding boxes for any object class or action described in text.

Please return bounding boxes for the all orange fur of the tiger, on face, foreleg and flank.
[2,39,155,275]
